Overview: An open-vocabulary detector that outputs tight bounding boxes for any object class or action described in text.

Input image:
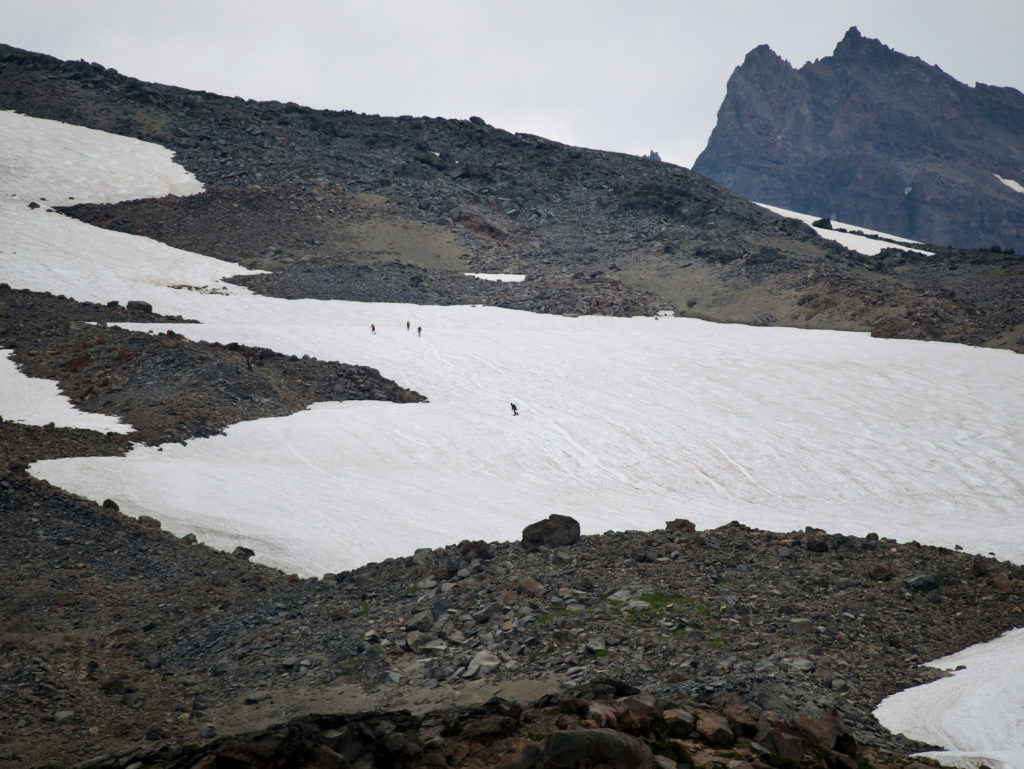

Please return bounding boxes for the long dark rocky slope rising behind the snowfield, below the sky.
[0,46,1024,349]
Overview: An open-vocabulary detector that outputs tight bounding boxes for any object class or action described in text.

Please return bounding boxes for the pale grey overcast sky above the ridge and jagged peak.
[6,0,1024,166]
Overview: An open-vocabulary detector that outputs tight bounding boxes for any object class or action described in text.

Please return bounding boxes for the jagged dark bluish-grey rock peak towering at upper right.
[693,28,1024,253]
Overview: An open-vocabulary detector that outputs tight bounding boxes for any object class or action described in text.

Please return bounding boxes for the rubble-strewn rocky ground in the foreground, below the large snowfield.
[0,450,1024,767]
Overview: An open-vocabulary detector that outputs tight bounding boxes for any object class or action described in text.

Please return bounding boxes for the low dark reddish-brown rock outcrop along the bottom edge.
[58,691,888,769]
